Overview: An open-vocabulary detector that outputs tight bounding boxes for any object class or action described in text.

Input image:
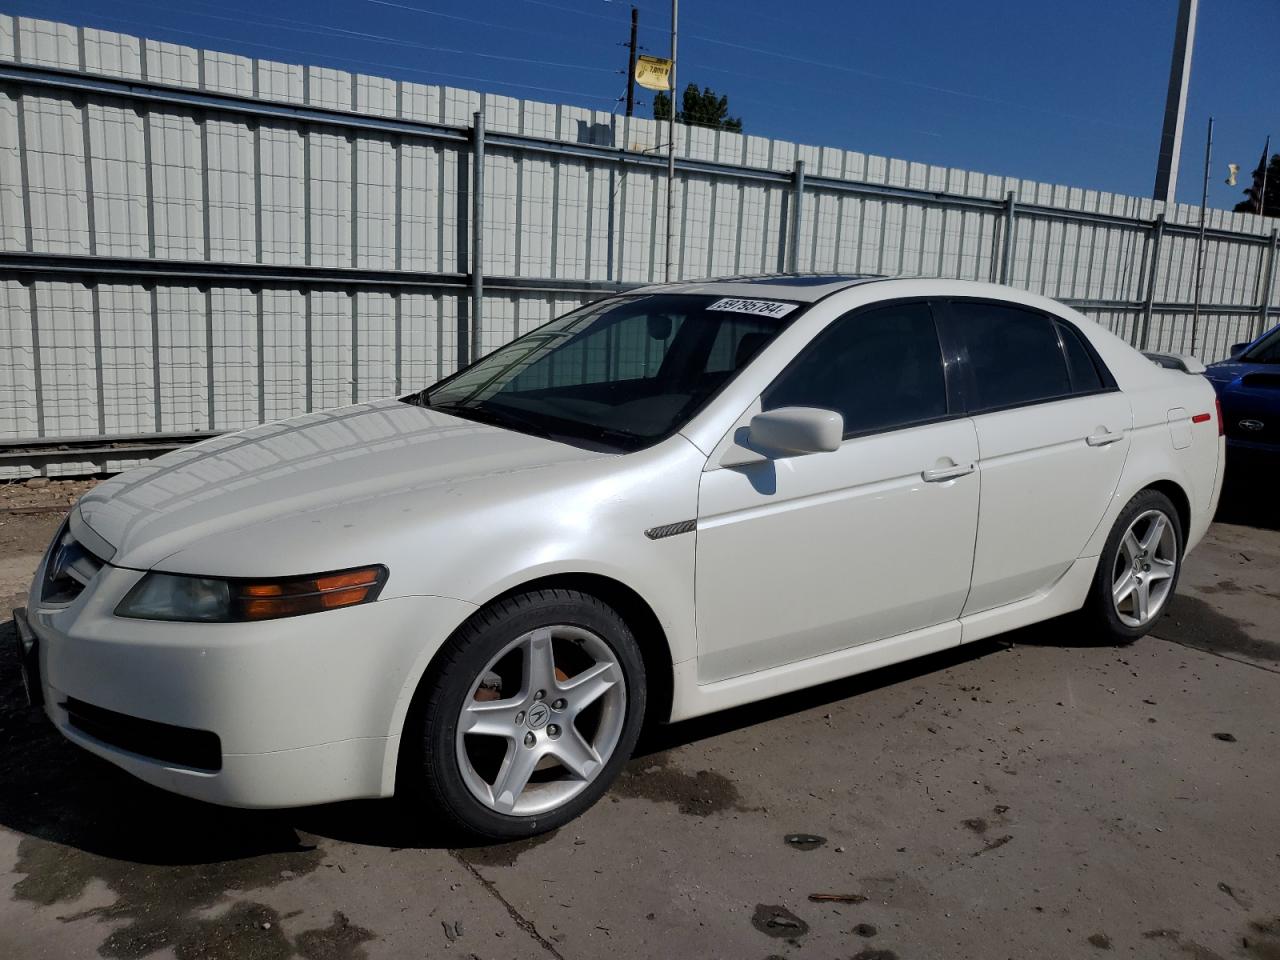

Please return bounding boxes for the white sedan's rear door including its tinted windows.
[937,300,1133,616]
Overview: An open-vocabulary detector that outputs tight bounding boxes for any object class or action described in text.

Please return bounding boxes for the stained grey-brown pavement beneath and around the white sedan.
[0,488,1280,960]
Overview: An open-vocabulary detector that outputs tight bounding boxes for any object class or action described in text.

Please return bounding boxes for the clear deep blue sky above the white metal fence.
[12,0,1280,206]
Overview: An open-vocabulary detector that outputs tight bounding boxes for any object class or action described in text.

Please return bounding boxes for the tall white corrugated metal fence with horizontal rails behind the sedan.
[0,17,1280,477]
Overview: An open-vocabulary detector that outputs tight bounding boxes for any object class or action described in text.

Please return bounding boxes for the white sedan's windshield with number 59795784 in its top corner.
[404,293,801,451]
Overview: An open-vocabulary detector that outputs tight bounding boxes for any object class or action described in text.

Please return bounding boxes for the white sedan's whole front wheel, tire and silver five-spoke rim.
[402,590,645,840]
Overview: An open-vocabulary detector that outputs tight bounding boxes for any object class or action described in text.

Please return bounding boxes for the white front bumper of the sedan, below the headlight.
[27,566,475,808]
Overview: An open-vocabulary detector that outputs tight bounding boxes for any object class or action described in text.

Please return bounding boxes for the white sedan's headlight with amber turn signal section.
[115,566,387,623]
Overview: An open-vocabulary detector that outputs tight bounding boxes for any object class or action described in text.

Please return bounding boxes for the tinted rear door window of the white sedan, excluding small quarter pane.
[951,301,1071,411]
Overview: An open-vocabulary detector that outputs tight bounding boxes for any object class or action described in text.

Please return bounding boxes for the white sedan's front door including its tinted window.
[695,301,978,682]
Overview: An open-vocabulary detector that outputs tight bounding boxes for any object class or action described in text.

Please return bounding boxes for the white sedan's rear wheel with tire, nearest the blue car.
[1083,490,1183,643]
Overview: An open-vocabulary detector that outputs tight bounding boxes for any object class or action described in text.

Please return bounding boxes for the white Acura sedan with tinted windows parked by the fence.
[18,276,1224,838]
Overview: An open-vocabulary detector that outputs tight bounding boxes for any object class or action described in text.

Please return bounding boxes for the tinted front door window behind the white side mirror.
[760,303,947,436]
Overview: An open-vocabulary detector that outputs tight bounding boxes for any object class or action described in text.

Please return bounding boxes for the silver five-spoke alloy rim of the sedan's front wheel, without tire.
[456,625,627,817]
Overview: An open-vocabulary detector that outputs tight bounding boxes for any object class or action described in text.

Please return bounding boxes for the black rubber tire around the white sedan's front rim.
[397,589,645,841]
